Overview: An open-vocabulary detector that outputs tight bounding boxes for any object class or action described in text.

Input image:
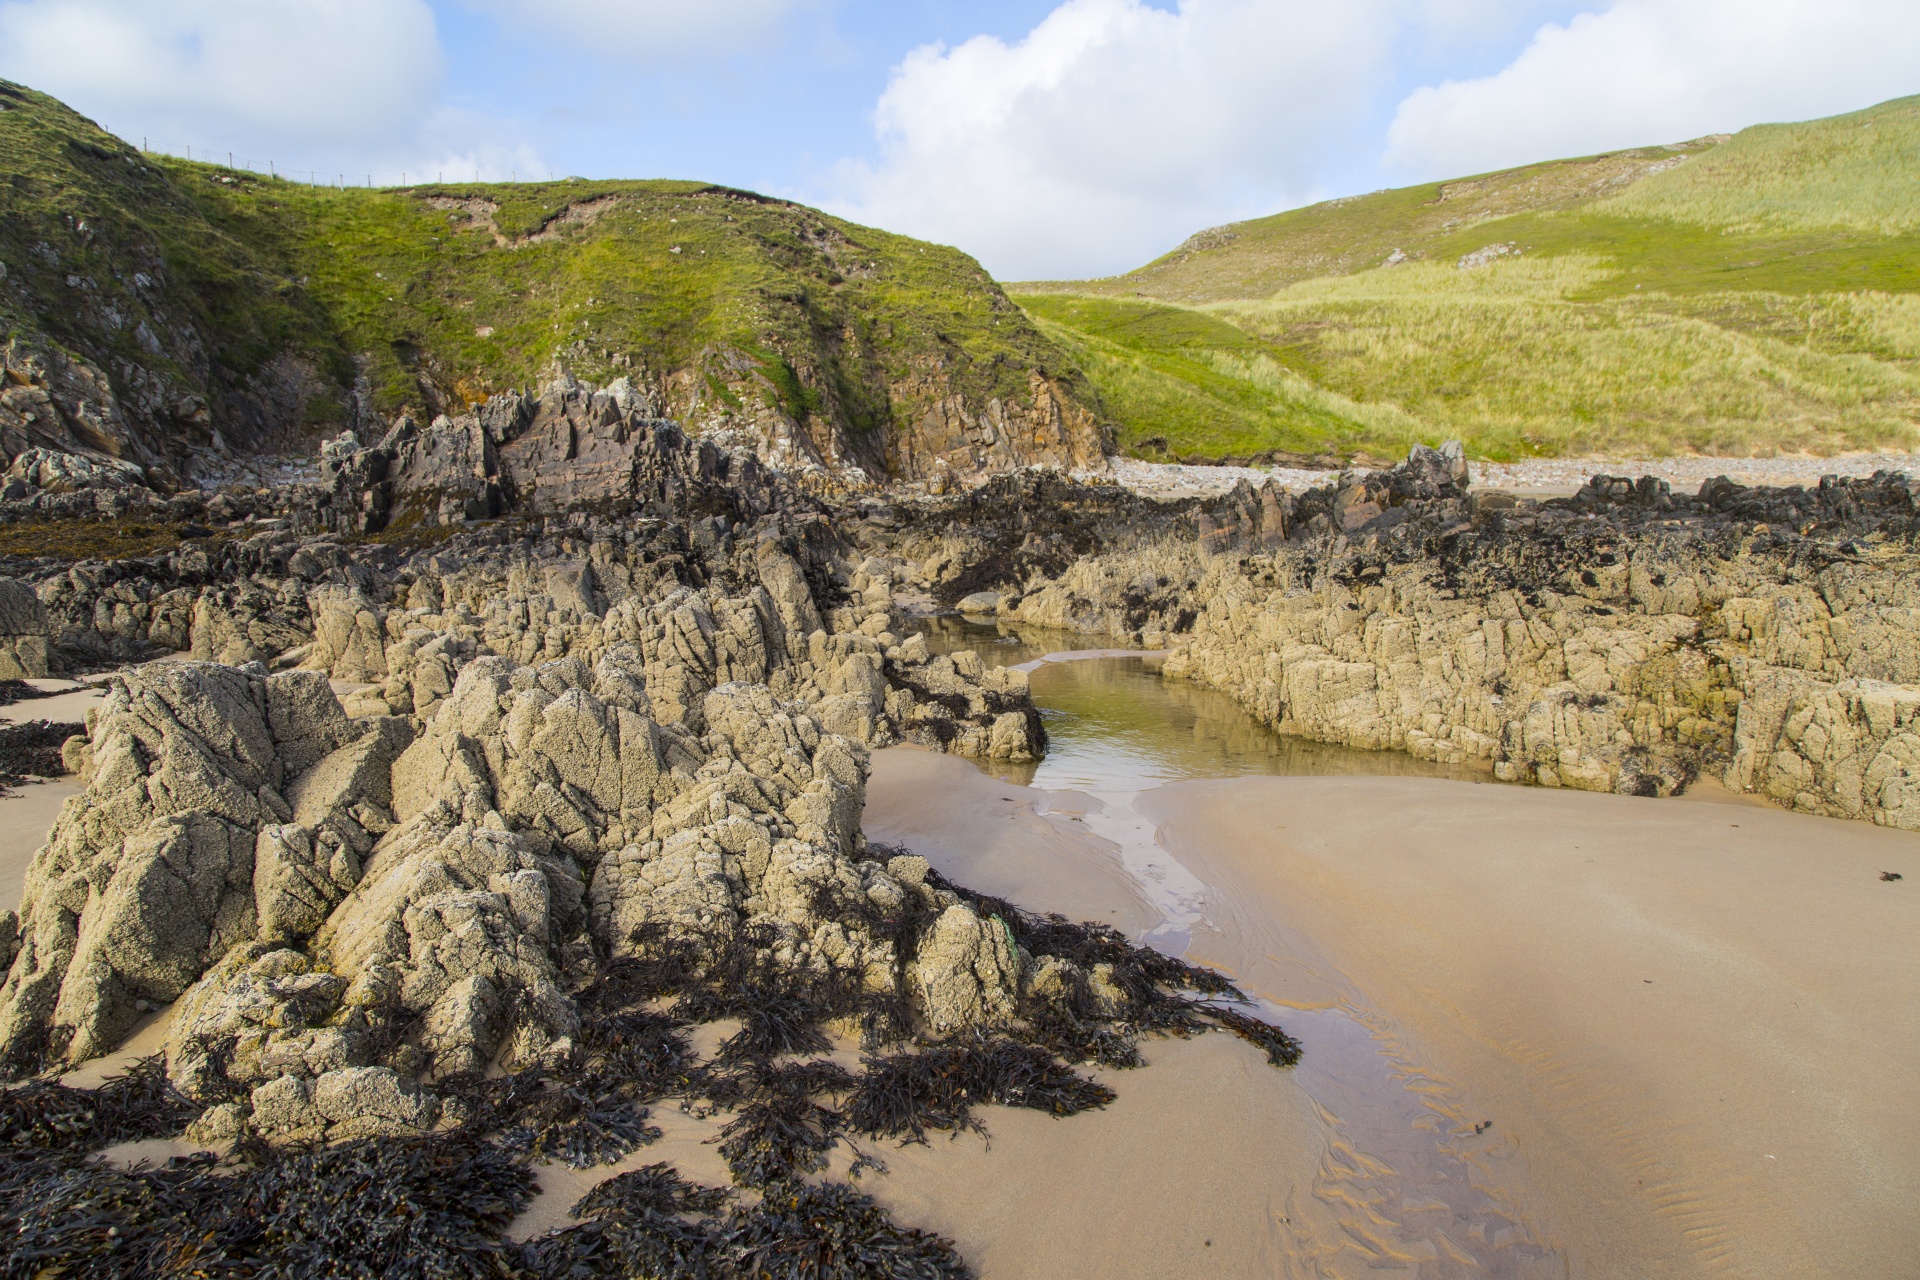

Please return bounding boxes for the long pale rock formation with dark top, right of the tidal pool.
[862,447,1920,829]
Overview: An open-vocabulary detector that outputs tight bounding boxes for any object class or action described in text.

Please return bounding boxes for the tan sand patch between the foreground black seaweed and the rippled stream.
[864,1034,1334,1280]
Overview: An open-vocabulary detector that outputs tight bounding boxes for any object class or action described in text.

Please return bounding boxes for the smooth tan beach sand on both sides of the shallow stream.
[868,752,1920,1280]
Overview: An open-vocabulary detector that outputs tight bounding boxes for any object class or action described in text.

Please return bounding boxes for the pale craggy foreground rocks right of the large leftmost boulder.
[140,629,1020,1138]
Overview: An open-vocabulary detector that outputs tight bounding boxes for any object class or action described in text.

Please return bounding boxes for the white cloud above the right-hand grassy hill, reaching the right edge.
[1386,0,1920,177]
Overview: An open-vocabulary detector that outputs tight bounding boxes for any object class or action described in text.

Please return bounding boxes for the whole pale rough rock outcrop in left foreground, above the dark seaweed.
[0,643,1044,1140]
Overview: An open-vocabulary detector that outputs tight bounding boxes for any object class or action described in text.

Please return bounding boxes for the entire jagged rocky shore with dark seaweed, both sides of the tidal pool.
[0,382,1920,1274]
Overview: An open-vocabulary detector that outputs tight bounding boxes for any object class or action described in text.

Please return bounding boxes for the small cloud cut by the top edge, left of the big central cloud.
[467,0,814,61]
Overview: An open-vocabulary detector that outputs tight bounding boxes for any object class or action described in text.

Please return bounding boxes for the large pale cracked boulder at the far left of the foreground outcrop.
[0,662,366,1065]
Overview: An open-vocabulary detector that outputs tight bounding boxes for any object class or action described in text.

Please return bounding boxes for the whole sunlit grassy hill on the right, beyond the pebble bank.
[1012,98,1920,459]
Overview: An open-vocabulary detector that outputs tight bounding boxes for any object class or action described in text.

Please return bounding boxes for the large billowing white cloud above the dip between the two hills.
[829,0,1394,278]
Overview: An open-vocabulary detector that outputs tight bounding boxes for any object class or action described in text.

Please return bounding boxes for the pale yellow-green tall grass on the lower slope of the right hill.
[1210,255,1920,457]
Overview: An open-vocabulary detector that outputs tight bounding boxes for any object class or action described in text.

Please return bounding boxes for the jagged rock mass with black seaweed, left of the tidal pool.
[0,388,1298,1276]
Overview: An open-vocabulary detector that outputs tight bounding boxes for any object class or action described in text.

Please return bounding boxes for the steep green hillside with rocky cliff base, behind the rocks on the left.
[0,83,1102,482]
